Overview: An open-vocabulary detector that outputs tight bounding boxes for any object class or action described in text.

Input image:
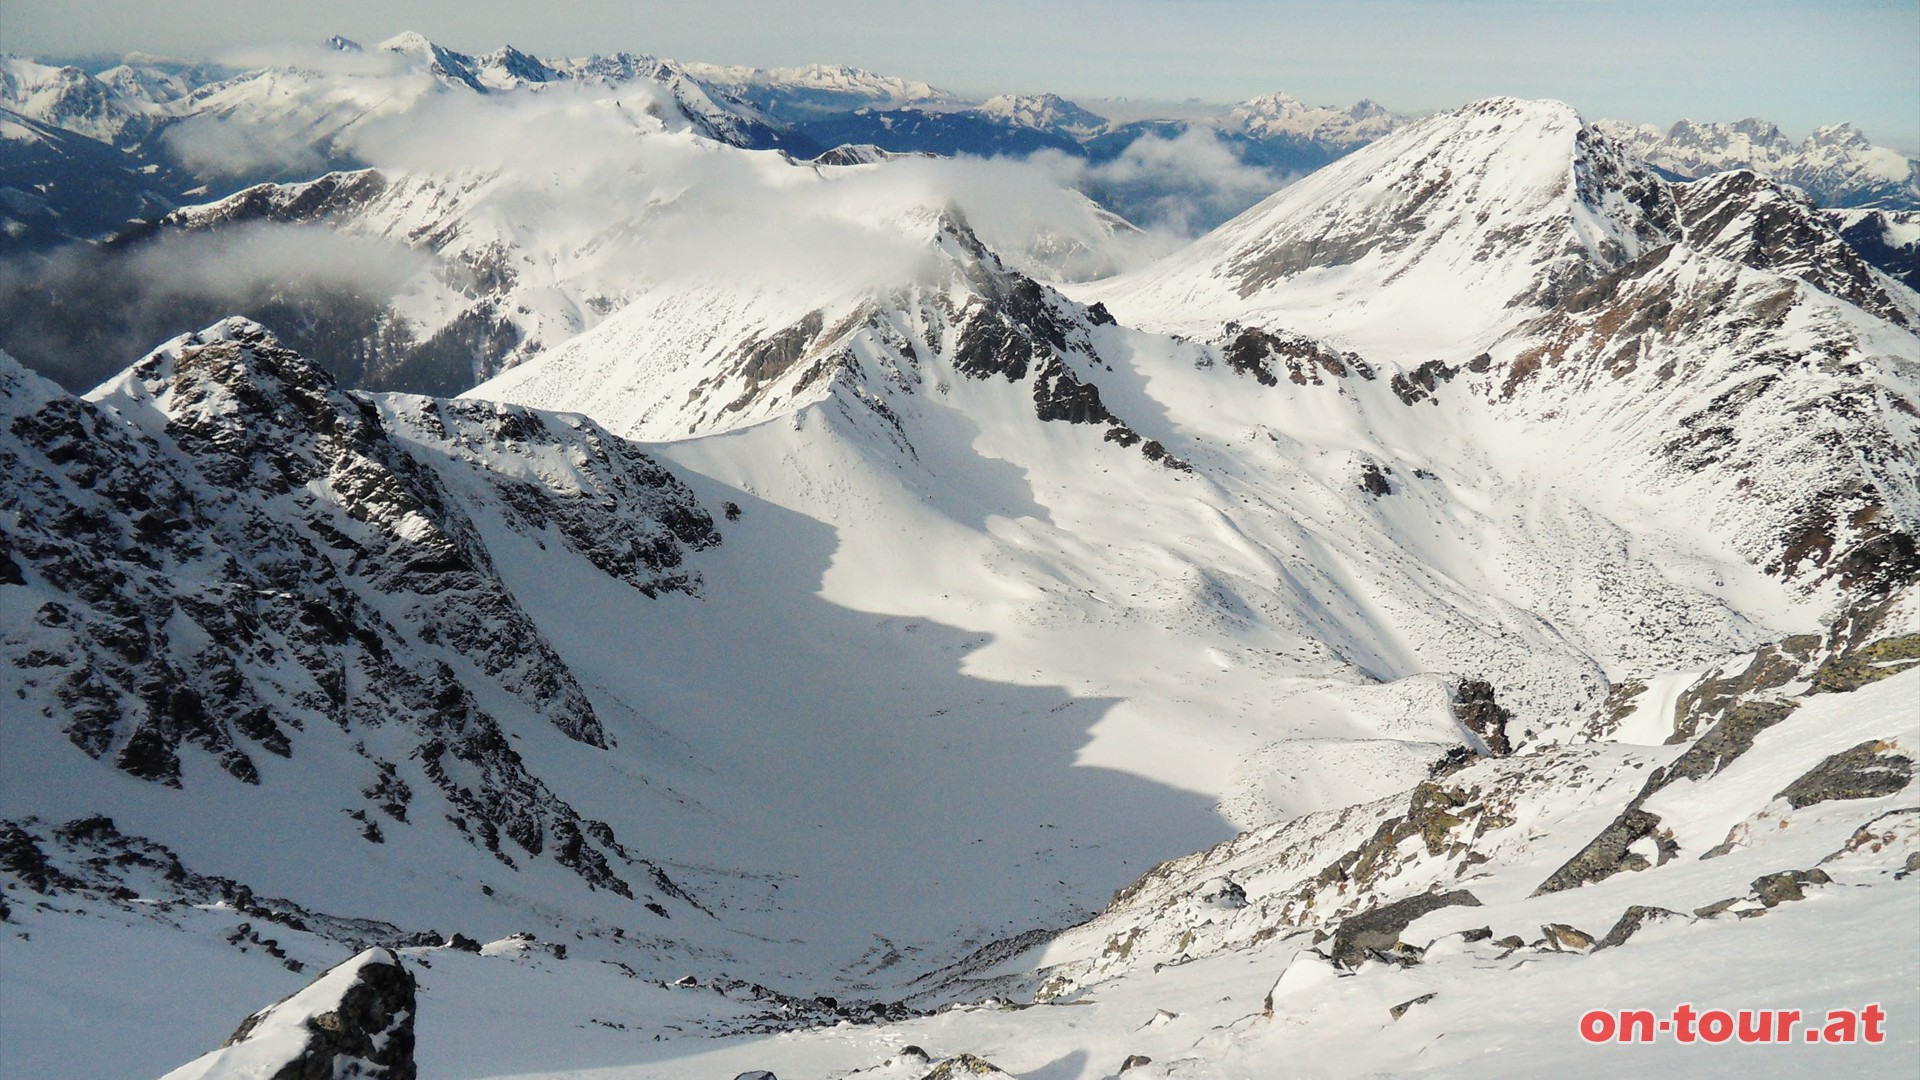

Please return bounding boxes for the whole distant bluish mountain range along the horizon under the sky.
[0,33,1920,252]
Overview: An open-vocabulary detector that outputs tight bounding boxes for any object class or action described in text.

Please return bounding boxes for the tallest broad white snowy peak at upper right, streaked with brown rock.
[1087,98,1678,349]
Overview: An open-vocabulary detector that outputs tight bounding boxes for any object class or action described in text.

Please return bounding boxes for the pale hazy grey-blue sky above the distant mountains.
[11,0,1920,152]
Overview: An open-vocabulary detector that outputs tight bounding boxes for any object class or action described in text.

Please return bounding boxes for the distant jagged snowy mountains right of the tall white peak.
[1601,119,1920,209]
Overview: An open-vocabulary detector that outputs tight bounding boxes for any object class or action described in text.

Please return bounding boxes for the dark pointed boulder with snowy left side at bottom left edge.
[165,949,419,1080]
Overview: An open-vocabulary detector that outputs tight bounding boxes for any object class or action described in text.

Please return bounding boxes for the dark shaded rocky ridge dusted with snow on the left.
[0,319,720,896]
